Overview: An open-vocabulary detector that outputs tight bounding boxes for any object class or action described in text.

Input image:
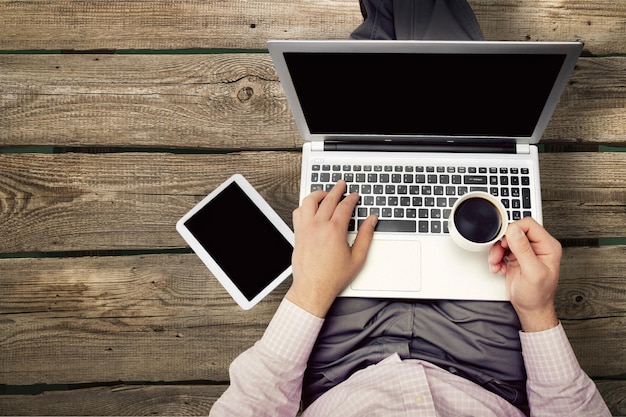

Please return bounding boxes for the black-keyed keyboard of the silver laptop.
[310,164,532,234]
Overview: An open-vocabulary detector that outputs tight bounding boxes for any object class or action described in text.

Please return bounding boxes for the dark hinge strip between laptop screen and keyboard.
[320,140,516,154]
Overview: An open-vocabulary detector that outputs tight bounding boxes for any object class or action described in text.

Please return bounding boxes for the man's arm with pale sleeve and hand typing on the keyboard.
[210,181,376,417]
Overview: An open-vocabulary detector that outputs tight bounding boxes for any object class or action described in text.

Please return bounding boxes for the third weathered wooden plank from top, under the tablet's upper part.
[0,152,626,253]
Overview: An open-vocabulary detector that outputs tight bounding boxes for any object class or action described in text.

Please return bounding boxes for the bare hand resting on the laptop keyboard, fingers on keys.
[286,180,378,317]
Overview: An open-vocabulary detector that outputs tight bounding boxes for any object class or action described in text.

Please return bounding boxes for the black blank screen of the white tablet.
[185,182,293,300]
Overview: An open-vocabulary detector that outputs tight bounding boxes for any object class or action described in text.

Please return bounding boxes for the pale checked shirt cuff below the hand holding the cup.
[520,323,582,383]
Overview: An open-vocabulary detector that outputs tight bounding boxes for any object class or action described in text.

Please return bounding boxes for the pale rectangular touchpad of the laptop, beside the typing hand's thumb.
[350,239,422,291]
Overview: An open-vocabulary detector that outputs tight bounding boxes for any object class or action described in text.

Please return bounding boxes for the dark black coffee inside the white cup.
[454,197,502,243]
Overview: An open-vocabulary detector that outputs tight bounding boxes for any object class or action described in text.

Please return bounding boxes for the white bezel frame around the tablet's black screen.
[176,174,294,310]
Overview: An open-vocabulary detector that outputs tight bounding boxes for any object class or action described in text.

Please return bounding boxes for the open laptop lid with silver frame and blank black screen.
[268,40,583,144]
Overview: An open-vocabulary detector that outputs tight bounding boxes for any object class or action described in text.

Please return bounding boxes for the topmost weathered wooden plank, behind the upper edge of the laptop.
[0,0,626,54]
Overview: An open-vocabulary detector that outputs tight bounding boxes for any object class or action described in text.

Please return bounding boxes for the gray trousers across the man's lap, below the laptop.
[302,298,528,414]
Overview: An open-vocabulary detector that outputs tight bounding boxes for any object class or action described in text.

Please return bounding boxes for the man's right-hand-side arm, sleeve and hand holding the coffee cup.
[489,217,610,417]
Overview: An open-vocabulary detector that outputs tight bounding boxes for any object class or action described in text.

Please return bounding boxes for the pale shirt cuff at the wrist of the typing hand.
[259,299,324,362]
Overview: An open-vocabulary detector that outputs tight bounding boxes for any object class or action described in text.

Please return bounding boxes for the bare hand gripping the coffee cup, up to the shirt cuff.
[489,217,562,332]
